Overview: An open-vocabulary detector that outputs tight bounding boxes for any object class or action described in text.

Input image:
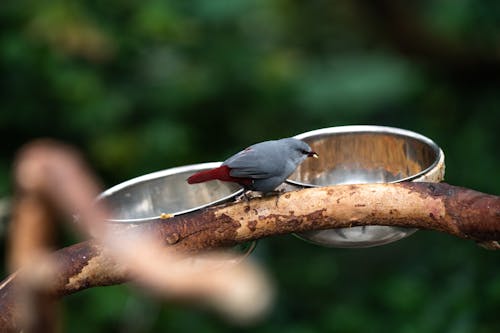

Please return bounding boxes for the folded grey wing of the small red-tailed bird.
[224,146,276,179]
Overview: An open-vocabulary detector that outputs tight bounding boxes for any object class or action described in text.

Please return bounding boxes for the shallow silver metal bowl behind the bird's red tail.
[98,162,243,223]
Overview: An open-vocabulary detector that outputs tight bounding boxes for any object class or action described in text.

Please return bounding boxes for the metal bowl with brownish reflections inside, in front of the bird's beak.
[287,126,444,248]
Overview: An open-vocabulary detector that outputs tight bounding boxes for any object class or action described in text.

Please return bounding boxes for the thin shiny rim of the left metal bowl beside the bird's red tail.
[96,162,243,223]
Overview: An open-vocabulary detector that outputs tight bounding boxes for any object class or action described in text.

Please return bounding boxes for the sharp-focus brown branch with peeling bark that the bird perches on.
[0,183,500,314]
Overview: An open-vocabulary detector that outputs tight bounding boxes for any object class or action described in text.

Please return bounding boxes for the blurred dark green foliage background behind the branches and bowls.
[0,0,500,333]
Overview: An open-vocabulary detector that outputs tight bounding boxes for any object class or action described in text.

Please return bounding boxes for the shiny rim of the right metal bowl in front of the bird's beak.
[286,125,443,187]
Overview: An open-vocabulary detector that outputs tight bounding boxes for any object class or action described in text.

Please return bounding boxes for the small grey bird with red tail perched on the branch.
[187,138,318,193]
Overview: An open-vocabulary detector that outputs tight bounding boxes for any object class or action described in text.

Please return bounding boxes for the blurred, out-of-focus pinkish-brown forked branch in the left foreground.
[0,140,272,333]
